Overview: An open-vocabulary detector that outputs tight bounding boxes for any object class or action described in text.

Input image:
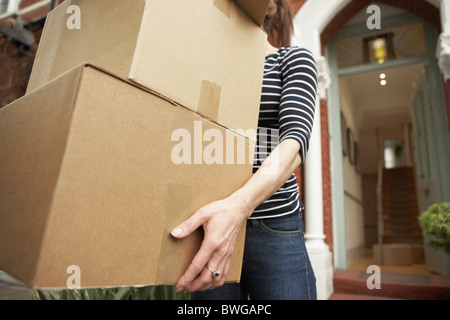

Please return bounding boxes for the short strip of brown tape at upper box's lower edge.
[198,80,222,121]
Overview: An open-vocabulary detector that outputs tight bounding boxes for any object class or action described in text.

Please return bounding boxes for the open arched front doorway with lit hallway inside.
[327,6,450,268]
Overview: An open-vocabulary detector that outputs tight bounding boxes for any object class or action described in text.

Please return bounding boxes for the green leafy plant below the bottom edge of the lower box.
[31,286,189,300]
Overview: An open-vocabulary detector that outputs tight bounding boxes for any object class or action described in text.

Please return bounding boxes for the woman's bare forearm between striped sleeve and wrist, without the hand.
[230,139,302,218]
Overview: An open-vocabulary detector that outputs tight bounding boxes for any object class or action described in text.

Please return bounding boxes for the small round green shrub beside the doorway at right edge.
[419,202,450,254]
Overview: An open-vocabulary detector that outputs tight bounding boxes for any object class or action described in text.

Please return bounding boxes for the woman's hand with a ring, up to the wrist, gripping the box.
[172,194,253,292]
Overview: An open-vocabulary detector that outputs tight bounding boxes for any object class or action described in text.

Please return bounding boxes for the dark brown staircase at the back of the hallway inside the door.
[382,167,422,243]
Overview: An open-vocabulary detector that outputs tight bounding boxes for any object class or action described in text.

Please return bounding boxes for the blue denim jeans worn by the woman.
[191,215,317,300]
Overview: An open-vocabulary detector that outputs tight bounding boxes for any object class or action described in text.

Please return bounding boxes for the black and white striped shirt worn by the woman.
[250,47,317,219]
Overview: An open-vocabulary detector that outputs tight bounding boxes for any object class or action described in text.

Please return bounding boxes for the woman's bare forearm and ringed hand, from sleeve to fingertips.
[172,139,301,292]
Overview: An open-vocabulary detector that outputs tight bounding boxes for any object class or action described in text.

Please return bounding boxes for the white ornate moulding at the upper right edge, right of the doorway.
[436,0,450,81]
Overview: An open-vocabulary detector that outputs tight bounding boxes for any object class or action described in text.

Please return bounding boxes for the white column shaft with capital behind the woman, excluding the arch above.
[304,57,333,300]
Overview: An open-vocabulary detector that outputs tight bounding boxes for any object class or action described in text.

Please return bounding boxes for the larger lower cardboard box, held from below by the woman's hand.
[0,65,254,288]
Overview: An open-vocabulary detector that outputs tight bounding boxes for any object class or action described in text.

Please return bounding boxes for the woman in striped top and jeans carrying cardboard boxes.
[172,0,317,300]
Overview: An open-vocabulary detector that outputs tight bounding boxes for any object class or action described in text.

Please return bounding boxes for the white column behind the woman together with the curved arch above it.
[292,0,351,300]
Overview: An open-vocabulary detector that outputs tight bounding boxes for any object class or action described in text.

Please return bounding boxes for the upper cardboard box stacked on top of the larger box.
[27,0,269,141]
